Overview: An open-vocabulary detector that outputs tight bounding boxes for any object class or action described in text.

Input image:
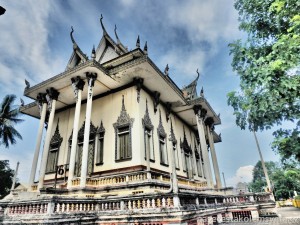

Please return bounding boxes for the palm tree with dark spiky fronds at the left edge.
[0,95,23,148]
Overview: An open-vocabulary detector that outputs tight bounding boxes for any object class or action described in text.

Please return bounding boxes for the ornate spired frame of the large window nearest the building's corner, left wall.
[113,95,134,162]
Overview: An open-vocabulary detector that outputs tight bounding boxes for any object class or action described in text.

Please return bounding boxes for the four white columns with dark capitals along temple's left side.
[29,73,97,189]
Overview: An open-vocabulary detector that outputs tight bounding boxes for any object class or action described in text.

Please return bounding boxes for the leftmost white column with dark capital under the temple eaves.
[29,93,47,186]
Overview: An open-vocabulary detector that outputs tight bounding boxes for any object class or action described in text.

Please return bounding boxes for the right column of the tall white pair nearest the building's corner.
[80,73,97,188]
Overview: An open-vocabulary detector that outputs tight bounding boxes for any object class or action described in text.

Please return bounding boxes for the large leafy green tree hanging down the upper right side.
[228,0,300,161]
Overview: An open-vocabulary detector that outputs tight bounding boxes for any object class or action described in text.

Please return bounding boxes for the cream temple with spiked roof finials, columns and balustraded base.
[0,16,273,225]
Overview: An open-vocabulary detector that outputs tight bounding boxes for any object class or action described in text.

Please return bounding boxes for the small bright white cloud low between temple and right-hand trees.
[226,165,254,187]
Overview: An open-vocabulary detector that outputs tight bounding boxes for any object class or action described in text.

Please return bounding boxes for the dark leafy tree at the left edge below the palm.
[0,160,14,199]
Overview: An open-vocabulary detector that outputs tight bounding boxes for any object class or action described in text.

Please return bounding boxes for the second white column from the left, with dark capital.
[38,88,59,189]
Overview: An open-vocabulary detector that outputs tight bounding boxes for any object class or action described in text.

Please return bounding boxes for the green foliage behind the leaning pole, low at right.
[249,161,300,199]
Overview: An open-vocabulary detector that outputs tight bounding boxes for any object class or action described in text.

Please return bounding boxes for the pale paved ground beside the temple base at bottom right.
[224,207,300,225]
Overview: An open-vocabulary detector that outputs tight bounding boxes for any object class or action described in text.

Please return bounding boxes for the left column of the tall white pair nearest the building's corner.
[67,77,84,189]
